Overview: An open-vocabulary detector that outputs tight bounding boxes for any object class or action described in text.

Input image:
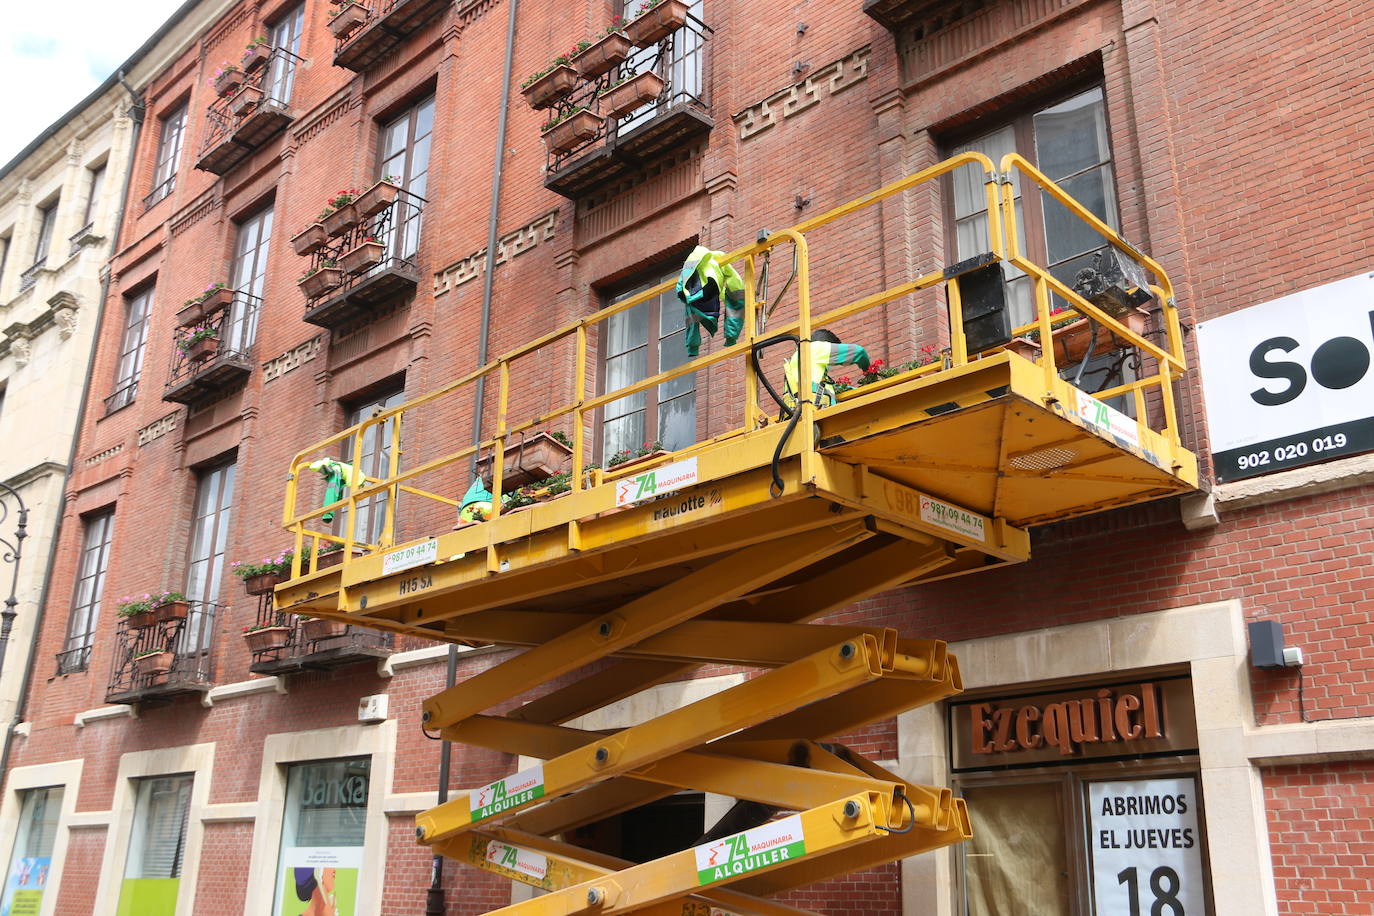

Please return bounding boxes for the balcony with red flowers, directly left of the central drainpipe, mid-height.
[304,191,427,328]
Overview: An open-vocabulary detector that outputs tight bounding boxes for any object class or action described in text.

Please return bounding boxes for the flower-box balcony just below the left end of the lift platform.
[249,595,394,674]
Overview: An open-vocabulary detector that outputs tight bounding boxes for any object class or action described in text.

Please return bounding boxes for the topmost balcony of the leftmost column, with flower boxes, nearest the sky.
[195,48,302,174]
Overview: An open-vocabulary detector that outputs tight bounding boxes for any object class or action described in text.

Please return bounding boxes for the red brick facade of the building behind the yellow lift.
[7,0,1374,916]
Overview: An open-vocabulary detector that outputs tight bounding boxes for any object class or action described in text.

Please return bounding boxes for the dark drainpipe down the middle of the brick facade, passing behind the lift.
[425,0,519,916]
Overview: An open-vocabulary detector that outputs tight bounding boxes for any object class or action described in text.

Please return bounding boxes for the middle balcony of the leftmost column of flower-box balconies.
[162,290,262,404]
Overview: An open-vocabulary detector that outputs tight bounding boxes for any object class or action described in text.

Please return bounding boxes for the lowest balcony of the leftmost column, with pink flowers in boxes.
[104,603,217,705]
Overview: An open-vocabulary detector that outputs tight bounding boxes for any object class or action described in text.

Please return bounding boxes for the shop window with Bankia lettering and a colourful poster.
[273,757,372,916]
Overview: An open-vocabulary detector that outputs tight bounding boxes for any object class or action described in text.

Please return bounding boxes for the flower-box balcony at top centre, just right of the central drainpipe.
[544,14,714,199]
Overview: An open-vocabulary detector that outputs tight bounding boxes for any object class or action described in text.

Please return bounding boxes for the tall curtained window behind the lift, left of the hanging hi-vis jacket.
[602,275,697,463]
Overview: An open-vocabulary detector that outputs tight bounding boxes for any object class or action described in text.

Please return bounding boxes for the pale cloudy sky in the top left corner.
[0,0,189,165]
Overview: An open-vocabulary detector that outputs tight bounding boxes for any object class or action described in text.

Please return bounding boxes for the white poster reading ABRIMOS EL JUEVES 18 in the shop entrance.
[1088,776,1206,916]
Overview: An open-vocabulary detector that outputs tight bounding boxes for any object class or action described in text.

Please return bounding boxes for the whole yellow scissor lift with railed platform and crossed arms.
[275,152,1197,916]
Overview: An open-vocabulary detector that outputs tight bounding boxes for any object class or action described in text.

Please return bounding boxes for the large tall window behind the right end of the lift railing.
[952,88,1118,325]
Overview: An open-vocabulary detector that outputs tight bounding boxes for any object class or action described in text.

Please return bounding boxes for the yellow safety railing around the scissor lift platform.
[282,152,1183,578]
